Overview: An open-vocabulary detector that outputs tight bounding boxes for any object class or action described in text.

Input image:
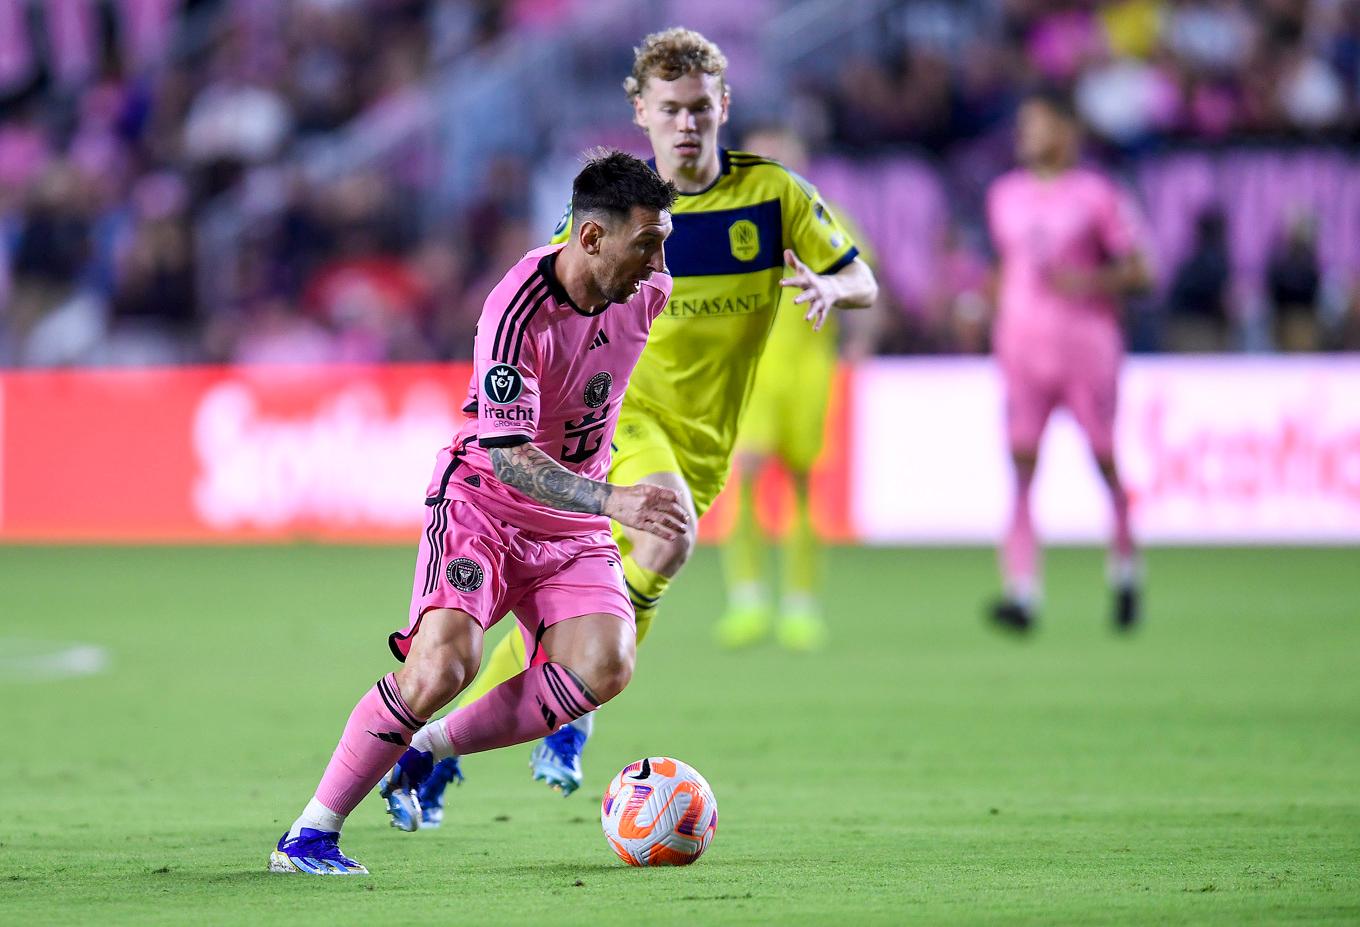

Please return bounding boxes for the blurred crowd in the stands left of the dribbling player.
[0,0,563,366]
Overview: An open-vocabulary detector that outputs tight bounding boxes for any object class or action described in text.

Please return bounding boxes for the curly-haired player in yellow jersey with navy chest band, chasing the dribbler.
[408,29,879,810]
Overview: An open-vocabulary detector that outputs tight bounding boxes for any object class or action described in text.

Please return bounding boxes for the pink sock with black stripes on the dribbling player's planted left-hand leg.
[317,673,424,816]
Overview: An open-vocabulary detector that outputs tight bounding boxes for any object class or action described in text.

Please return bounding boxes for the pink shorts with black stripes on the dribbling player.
[388,497,635,661]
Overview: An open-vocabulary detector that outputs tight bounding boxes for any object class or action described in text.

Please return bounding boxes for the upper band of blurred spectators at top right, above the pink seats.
[820,0,1360,151]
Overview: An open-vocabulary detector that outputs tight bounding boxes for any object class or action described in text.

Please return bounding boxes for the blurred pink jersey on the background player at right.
[987,169,1141,374]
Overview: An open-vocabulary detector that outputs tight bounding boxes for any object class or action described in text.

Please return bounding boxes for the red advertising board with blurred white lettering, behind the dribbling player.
[0,364,849,542]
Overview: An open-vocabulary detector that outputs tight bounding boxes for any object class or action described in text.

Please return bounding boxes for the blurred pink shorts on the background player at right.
[1002,353,1119,457]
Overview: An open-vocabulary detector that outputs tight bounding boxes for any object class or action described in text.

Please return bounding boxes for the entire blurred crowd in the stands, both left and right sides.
[0,0,1360,366]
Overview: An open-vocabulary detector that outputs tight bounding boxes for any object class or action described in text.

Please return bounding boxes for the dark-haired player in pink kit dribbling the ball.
[269,152,688,875]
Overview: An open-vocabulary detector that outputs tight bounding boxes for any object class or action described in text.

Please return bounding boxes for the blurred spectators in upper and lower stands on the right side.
[798,0,1360,353]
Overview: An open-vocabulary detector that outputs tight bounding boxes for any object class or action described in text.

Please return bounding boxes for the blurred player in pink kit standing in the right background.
[987,94,1149,631]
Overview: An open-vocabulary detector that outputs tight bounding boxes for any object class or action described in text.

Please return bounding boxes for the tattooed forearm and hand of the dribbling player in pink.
[488,443,690,541]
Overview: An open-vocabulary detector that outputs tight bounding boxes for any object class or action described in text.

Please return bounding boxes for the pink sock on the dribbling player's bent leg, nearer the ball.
[441,663,598,754]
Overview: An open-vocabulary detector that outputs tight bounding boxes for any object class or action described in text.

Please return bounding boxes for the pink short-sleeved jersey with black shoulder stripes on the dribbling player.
[426,245,670,536]
